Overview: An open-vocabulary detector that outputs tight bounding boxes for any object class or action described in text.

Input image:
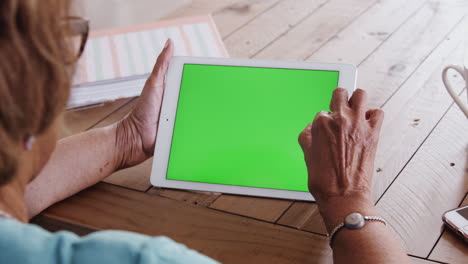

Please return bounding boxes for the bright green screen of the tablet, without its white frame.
[166,64,339,192]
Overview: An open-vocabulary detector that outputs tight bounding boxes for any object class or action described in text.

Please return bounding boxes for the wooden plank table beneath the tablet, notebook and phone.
[35,0,468,263]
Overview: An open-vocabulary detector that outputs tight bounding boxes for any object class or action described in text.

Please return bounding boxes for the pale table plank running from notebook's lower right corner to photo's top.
[225,0,329,58]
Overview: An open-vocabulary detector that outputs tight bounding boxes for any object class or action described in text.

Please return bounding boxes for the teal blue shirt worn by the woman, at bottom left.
[0,219,217,264]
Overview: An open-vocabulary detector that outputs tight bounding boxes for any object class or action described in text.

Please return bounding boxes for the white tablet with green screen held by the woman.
[151,57,356,200]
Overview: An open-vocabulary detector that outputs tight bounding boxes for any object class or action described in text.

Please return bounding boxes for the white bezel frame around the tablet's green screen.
[150,57,357,201]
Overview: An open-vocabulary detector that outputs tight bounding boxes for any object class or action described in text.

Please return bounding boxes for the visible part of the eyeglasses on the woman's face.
[64,16,89,61]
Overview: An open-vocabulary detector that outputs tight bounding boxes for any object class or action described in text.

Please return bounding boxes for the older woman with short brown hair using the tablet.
[0,0,408,264]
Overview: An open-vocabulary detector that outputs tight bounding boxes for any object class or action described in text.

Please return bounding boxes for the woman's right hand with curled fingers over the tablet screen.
[299,88,384,232]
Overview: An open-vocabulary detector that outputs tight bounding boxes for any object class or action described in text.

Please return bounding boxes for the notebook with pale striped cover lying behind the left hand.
[68,16,228,109]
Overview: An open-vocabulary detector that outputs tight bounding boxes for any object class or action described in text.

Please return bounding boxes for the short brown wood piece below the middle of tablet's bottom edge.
[210,194,292,223]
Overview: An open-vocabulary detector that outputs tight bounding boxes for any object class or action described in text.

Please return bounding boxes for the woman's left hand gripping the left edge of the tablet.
[115,39,174,169]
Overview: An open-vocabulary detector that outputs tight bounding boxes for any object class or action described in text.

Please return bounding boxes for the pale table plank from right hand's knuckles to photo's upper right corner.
[358,0,468,107]
